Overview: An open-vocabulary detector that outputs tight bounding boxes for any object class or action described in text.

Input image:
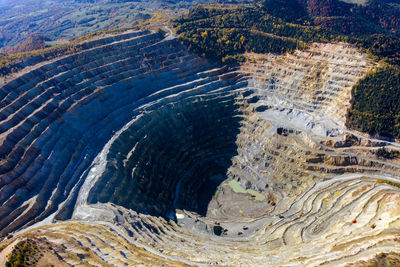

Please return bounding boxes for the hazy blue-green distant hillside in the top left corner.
[0,0,225,52]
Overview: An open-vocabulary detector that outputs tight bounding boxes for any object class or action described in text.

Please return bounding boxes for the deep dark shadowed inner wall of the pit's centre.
[88,93,243,219]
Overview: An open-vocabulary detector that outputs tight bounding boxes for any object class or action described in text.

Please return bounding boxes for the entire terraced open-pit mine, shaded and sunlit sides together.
[0,32,400,266]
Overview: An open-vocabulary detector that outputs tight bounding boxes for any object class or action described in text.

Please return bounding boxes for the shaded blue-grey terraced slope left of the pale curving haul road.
[0,29,244,237]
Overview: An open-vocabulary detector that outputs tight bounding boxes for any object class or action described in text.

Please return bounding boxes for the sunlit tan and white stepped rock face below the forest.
[242,44,371,127]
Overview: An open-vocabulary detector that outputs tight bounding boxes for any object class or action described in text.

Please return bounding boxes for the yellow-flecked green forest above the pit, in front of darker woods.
[174,5,347,63]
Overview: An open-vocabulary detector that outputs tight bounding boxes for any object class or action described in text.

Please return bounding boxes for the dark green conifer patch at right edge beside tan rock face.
[347,34,400,139]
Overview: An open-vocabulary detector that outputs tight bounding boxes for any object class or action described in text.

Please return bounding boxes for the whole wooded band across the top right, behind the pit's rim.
[174,0,400,62]
